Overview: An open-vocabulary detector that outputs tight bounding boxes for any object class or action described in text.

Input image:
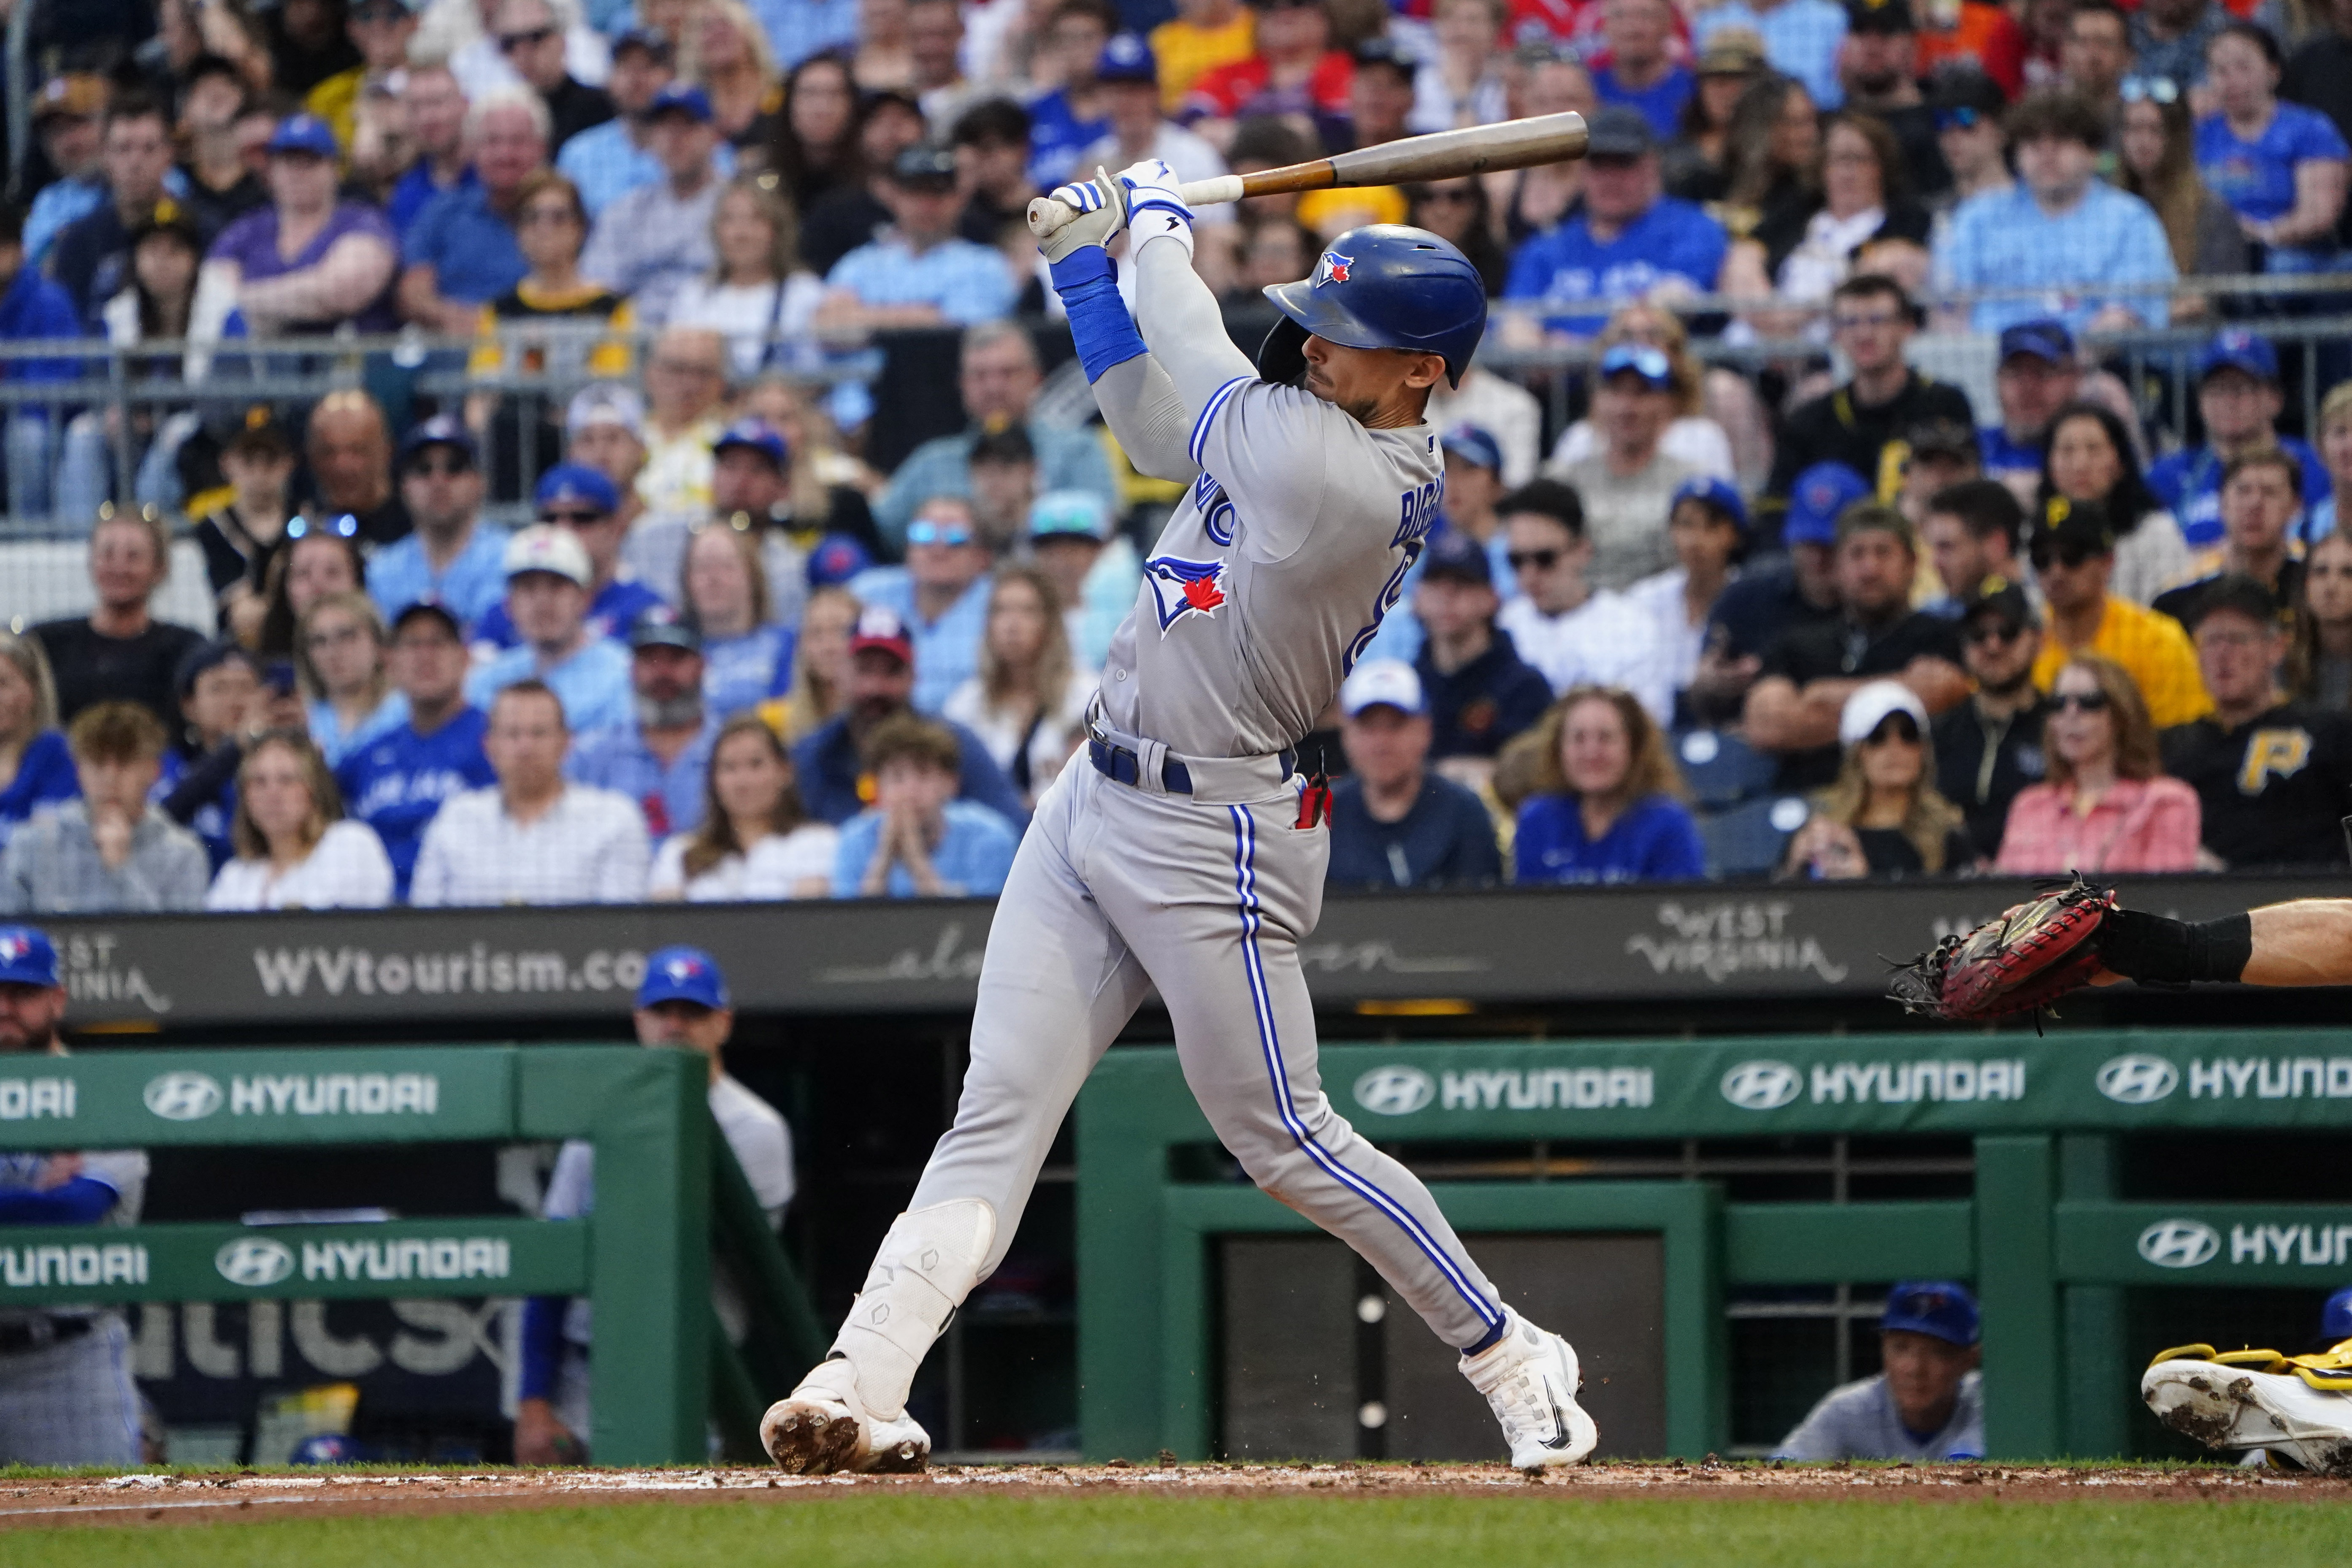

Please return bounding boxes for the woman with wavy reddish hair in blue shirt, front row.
[1512,686,1708,886]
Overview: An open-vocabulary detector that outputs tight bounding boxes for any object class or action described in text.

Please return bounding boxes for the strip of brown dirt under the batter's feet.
[0,1460,2352,1530]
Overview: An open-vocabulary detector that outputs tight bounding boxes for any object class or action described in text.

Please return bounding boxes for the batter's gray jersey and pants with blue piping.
[910,227,1501,1347]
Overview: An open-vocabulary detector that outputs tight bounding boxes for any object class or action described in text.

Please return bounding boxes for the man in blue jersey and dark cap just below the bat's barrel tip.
[1503,103,1731,336]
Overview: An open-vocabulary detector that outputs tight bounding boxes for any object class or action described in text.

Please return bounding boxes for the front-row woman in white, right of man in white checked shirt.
[649,712,835,903]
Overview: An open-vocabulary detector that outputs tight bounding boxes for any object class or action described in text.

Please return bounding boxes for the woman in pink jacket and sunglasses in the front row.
[1995,653,2201,875]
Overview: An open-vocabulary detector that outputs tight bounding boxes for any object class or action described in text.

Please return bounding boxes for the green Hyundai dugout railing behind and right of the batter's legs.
[1077,1030,2352,1460]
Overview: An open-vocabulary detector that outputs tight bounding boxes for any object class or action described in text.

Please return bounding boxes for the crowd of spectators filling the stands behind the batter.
[0,0,2352,912]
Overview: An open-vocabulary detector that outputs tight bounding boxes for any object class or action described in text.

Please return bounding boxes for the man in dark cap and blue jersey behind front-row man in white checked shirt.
[334,599,498,903]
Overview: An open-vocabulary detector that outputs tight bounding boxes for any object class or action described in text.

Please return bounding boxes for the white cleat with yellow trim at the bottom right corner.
[2140,1340,2352,1476]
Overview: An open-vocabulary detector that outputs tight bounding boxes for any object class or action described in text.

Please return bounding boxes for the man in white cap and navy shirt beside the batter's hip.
[1324,658,1503,888]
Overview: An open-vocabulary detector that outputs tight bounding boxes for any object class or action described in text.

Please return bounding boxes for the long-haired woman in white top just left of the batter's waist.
[939,566,1101,806]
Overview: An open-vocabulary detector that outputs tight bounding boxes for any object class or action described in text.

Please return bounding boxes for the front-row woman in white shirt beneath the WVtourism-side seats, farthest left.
[205,729,393,910]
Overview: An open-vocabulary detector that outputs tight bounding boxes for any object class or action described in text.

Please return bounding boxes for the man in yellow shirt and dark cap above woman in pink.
[2027,496,2213,729]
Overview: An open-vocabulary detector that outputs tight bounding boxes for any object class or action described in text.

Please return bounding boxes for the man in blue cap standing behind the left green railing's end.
[515,948,793,1465]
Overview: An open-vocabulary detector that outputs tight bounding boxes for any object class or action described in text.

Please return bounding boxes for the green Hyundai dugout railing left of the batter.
[0,1046,826,1465]
